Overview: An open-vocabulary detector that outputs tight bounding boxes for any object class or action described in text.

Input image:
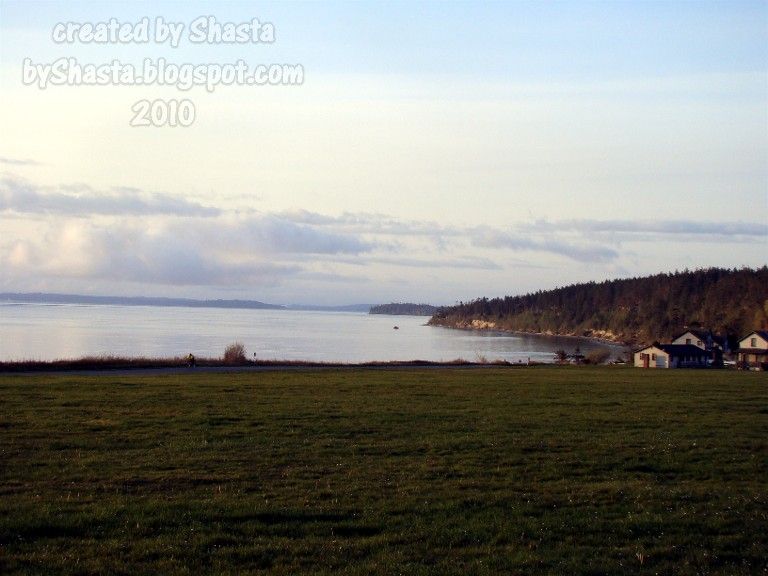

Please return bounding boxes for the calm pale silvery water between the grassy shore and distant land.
[0,303,622,362]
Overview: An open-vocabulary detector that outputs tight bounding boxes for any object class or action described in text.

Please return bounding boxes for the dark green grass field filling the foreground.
[0,367,768,575]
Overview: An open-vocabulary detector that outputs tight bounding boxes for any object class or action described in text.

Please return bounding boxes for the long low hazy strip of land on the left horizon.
[0,292,285,310]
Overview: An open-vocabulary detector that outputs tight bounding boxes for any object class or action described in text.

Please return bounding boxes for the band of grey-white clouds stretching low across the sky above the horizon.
[0,175,768,302]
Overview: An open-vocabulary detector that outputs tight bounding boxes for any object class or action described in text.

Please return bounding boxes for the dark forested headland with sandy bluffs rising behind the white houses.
[429,266,768,343]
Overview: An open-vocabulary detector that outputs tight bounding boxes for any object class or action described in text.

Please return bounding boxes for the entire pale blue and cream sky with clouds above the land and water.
[0,0,768,305]
